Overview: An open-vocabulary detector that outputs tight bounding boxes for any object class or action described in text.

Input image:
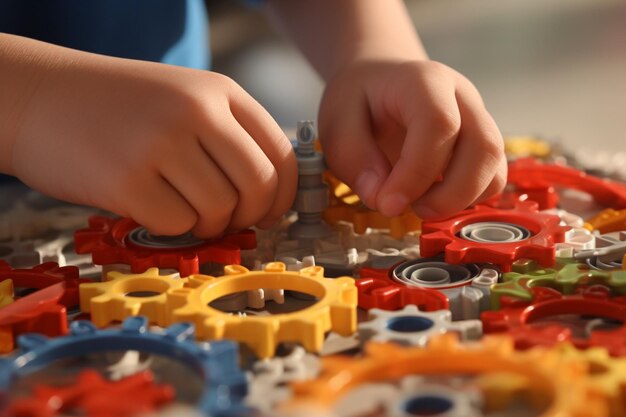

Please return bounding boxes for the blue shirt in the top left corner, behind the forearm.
[0,0,210,69]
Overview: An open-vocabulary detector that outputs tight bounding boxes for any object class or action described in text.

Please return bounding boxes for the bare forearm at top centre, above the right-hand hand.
[269,0,427,80]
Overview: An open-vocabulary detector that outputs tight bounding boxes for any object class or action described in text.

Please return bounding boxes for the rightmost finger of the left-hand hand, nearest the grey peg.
[230,85,298,225]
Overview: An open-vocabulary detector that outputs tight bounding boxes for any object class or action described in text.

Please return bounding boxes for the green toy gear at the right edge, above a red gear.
[491,264,626,310]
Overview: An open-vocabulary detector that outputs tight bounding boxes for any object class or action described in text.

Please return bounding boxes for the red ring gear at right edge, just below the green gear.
[481,285,626,356]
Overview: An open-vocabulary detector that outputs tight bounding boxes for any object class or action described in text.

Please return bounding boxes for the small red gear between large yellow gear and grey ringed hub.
[355,268,449,311]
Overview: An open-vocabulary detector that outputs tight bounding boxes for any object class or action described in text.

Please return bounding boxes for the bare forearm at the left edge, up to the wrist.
[0,33,83,174]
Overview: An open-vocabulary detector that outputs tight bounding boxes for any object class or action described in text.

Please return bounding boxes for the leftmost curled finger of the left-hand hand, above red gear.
[120,172,198,236]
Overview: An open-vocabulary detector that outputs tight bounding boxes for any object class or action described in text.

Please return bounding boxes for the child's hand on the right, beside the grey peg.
[319,61,507,218]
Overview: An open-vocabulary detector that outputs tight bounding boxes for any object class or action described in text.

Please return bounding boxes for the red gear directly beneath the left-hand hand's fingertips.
[74,216,256,277]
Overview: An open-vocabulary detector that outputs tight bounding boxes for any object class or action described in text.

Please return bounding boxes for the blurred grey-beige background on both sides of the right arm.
[208,0,626,152]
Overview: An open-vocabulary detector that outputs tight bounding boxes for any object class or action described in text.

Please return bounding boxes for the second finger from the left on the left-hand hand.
[160,139,238,238]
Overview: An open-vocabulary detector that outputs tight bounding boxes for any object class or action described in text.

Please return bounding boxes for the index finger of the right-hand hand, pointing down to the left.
[376,67,461,216]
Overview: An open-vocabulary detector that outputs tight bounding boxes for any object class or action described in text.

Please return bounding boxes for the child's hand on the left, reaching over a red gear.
[3,37,298,237]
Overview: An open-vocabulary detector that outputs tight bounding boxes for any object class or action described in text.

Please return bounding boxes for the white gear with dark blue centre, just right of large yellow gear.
[359,305,483,346]
